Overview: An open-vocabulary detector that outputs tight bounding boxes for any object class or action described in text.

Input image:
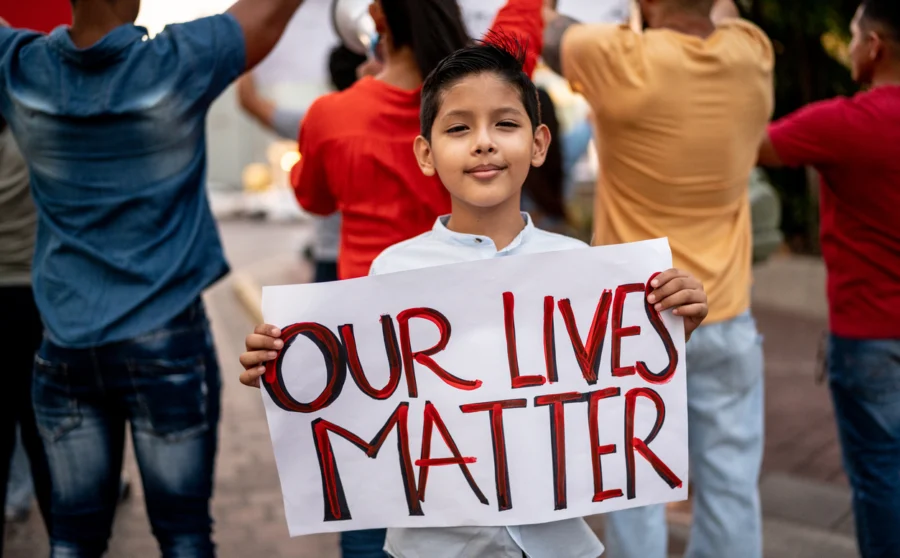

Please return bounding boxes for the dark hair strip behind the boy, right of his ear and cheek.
[522,89,566,221]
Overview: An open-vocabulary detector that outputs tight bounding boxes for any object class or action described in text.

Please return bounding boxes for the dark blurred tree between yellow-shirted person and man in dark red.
[738,0,859,253]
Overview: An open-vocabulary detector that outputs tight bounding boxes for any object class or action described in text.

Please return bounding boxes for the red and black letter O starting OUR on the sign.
[263,322,347,413]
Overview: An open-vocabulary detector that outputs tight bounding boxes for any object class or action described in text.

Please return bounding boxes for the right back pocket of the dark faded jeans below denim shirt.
[128,356,209,441]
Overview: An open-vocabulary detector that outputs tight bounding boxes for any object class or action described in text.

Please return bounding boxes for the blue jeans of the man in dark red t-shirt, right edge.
[828,335,900,558]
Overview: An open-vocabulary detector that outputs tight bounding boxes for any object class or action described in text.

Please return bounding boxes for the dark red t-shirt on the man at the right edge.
[769,86,900,339]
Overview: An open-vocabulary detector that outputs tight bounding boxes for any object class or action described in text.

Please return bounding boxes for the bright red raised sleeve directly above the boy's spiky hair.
[484,0,544,77]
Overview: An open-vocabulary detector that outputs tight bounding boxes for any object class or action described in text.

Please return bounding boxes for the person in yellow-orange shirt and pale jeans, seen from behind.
[543,0,774,558]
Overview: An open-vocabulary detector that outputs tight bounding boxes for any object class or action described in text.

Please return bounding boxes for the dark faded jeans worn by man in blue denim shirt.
[34,300,220,558]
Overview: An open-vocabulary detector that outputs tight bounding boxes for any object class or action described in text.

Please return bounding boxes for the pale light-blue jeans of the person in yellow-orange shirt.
[604,312,764,558]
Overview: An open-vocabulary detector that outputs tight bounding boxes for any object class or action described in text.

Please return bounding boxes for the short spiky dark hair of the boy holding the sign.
[420,39,541,141]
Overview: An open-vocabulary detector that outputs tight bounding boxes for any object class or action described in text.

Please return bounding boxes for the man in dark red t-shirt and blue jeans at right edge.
[759,0,900,558]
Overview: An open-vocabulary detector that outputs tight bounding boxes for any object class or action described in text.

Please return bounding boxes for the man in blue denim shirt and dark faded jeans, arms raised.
[0,0,310,557]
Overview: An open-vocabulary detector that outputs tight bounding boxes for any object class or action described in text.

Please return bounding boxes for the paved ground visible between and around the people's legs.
[6,222,857,558]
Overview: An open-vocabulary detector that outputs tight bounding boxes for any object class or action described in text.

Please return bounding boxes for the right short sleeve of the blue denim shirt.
[154,13,247,105]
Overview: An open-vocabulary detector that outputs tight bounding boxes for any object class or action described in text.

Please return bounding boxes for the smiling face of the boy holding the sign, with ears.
[415,73,550,209]
